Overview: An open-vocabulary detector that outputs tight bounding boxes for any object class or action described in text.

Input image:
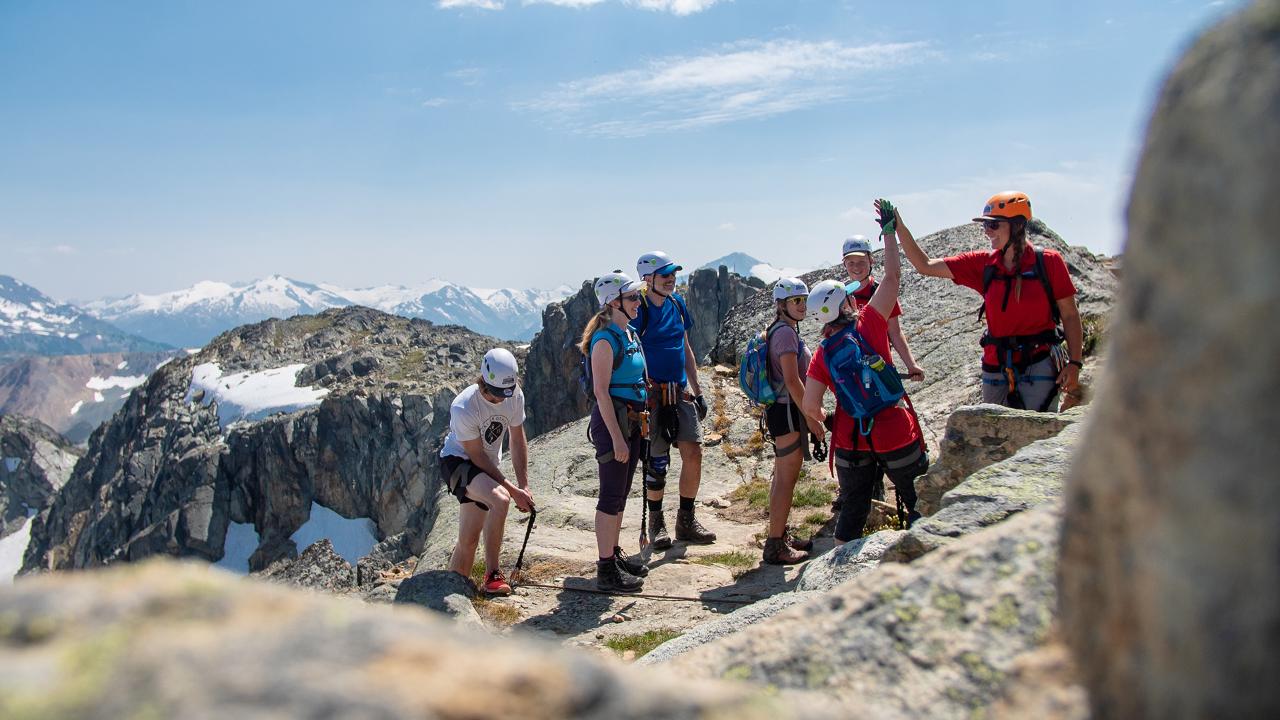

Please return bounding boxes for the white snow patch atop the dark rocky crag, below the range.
[187,363,329,430]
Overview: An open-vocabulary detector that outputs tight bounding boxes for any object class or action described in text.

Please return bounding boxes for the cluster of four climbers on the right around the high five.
[742,192,1083,564]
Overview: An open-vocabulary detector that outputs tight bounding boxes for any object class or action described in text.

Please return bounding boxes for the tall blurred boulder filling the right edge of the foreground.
[1061,1,1280,719]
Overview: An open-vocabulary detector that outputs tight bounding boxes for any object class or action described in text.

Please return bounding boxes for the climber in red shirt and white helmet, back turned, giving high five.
[801,198,929,544]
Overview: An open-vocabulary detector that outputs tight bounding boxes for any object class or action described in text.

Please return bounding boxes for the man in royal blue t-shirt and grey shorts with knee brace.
[631,251,716,550]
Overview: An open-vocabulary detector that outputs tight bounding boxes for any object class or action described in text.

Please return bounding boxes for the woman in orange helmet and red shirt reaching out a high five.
[893,192,1084,413]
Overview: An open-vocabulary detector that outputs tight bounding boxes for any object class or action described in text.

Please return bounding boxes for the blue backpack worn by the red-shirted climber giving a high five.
[822,325,906,436]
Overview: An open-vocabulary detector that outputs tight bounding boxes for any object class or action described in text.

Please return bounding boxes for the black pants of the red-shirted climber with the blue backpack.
[835,442,929,542]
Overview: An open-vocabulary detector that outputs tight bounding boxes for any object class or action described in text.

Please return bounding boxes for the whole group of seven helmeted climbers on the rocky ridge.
[440,192,1083,594]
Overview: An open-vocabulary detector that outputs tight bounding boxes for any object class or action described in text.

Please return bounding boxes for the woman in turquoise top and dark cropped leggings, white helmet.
[579,270,649,592]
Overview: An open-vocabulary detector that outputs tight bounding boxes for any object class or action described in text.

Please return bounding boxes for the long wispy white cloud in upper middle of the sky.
[517,40,932,137]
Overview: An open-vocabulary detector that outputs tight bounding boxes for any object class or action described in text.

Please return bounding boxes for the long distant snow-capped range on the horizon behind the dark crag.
[86,275,571,347]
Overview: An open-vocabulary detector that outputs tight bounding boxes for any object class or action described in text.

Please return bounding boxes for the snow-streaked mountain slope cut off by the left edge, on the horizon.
[0,275,165,360]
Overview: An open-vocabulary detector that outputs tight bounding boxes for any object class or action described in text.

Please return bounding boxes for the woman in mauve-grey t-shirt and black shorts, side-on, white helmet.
[764,278,823,565]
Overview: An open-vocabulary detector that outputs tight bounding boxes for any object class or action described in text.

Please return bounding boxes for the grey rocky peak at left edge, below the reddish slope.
[0,415,82,538]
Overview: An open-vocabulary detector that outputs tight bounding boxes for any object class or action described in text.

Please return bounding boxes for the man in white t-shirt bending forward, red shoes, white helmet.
[440,347,534,594]
